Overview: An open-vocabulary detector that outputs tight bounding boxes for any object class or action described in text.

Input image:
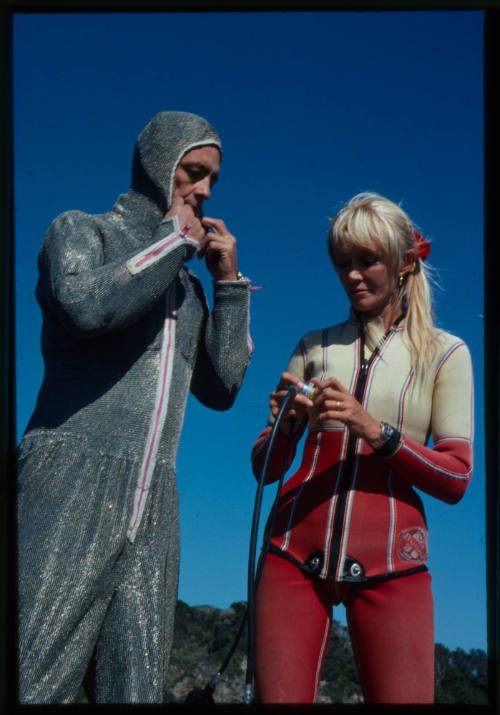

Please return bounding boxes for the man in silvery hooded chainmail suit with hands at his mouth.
[18,112,252,703]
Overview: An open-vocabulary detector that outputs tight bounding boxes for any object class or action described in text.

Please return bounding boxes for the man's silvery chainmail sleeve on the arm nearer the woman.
[191,279,253,410]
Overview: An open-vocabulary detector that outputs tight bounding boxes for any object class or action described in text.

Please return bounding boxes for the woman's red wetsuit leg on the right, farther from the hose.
[347,571,434,703]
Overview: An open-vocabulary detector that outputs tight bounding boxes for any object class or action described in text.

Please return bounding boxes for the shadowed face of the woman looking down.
[334,247,399,317]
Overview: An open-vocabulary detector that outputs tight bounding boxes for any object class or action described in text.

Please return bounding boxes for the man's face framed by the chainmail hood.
[172,146,221,216]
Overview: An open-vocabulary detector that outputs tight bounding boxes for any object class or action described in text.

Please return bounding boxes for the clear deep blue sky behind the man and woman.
[13,11,486,649]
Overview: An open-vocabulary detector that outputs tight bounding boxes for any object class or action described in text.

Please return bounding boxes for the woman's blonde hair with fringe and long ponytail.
[328,193,438,369]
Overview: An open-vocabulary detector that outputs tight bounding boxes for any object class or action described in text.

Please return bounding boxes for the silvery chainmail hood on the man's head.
[131,112,222,212]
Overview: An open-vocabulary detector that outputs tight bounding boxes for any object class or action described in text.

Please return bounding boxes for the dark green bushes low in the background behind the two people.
[167,601,488,705]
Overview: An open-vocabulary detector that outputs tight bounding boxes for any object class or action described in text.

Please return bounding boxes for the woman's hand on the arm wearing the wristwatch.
[310,377,380,442]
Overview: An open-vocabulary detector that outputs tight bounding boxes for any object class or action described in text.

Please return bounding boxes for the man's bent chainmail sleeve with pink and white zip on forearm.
[37,211,197,338]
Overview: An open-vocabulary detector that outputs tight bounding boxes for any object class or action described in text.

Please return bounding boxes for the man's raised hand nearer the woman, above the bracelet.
[198,216,238,281]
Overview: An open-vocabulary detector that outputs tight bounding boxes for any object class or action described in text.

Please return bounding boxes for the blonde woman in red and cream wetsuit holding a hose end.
[252,194,473,703]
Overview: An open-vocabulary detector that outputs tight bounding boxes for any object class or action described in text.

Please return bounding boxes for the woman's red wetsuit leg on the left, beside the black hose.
[255,554,331,703]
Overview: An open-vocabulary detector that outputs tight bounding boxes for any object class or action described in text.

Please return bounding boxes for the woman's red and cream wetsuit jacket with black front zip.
[252,312,473,704]
